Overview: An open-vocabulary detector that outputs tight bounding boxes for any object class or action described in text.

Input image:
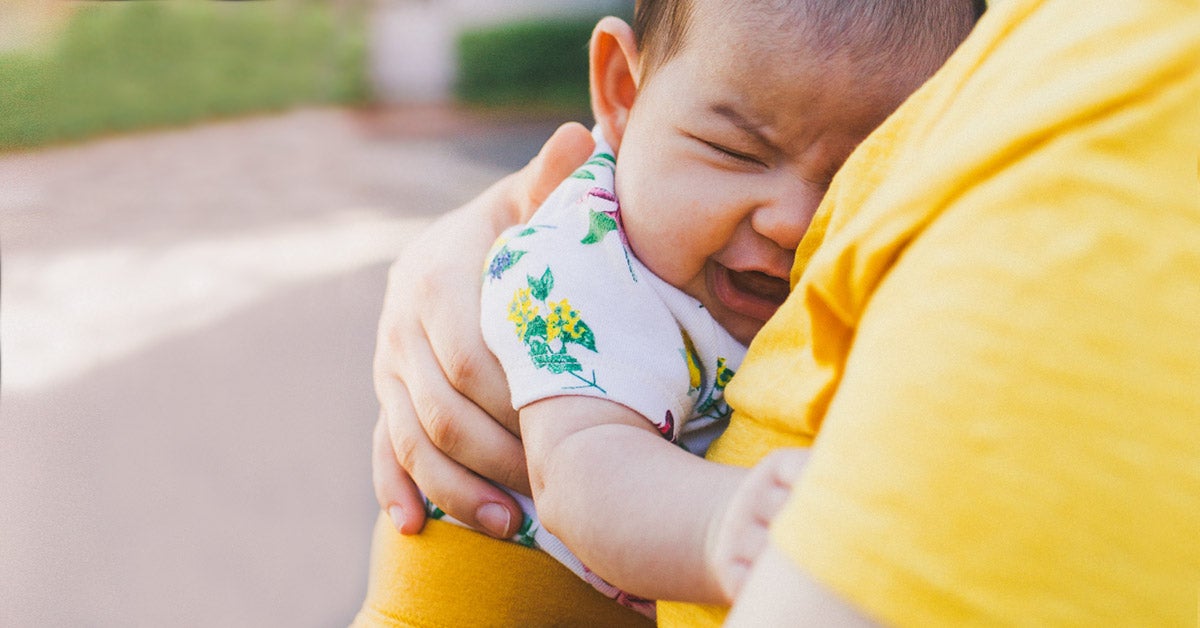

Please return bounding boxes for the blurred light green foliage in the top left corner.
[0,2,368,149]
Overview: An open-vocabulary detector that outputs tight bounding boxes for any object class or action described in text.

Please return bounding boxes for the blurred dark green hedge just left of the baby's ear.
[455,17,609,112]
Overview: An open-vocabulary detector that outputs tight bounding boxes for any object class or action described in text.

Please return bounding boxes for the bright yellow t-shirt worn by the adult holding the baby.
[660,0,1200,626]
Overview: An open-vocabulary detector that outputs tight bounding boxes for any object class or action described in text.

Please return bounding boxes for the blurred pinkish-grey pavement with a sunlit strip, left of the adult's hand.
[0,108,580,627]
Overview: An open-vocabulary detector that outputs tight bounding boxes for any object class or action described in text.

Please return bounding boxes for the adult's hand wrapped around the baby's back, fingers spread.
[372,122,594,538]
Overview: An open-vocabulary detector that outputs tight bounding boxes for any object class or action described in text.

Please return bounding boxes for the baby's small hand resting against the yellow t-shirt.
[708,449,809,603]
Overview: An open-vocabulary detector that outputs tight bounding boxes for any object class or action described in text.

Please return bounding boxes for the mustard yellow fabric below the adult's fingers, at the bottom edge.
[352,515,653,628]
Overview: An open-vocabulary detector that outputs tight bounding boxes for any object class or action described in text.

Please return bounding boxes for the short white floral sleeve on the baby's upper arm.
[481,181,691,436]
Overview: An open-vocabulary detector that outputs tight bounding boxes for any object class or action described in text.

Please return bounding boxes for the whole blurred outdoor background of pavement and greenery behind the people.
[0,0,632,627]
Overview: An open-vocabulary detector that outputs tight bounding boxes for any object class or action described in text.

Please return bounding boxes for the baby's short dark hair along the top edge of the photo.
[632,0,986,78]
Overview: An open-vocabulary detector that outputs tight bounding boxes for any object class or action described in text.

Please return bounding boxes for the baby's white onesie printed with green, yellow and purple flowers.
[465,128,745,616]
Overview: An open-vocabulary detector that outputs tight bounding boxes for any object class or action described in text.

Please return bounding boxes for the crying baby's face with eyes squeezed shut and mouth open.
[617,2,904,342]
